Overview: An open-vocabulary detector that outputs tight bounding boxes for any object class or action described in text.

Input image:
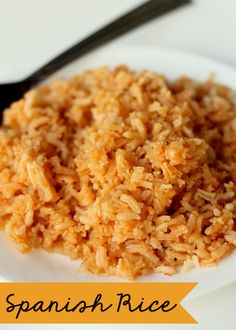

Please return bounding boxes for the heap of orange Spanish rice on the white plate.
[0,66,236,279]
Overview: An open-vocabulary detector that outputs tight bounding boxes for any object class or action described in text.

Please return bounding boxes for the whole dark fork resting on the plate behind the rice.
[0,0,191,118]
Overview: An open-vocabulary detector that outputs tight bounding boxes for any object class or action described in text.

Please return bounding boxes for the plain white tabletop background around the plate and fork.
[0,0,236,330]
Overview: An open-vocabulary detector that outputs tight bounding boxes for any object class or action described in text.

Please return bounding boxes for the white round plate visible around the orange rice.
[0,47,236,299]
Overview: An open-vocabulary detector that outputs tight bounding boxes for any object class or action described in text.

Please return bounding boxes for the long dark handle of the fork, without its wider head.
[25,0,191,85]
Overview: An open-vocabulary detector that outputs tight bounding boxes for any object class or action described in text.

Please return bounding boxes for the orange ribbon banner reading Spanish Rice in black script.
[0,282,197,323]
